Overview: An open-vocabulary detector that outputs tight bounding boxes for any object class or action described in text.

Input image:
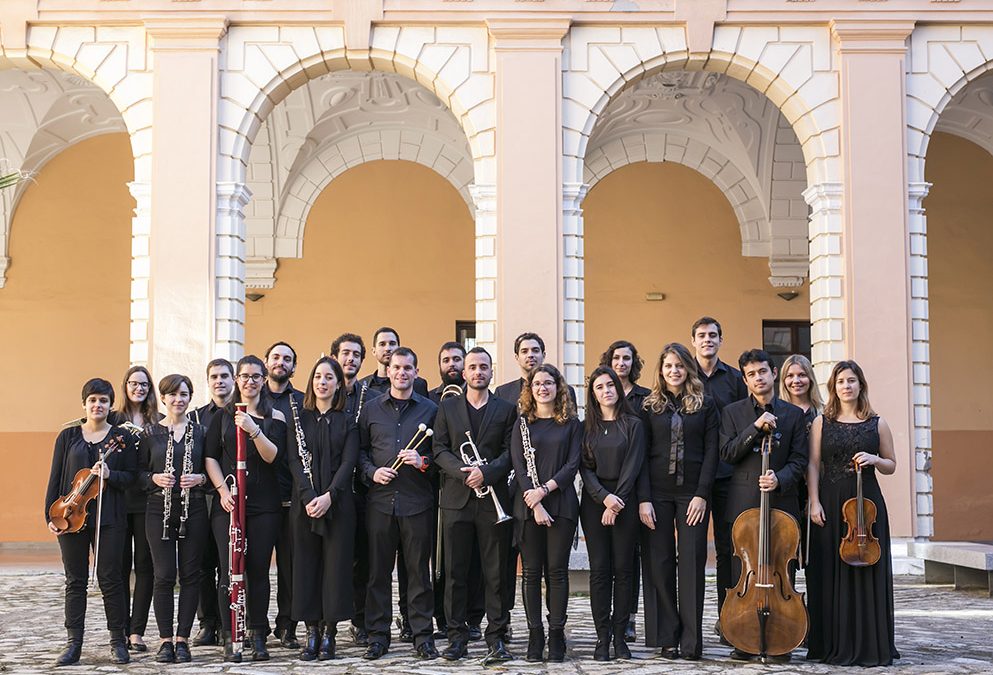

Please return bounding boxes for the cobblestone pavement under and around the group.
[0,566,993,675]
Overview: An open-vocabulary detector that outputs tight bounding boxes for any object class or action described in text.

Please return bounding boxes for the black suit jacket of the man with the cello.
[721,396,808,523]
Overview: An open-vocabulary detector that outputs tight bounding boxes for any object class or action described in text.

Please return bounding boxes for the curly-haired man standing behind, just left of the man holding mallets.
[331,333,382,647]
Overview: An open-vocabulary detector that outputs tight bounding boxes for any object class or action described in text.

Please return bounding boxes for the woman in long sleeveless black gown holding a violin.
[807,361,900,666]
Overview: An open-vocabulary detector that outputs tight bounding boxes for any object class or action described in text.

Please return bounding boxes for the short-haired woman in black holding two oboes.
[138,375,208,663]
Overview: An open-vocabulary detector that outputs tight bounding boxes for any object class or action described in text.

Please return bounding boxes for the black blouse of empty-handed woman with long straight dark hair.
[579,416,645,508]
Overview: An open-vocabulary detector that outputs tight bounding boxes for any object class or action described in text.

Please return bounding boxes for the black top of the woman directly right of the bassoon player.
[286,408,359,534]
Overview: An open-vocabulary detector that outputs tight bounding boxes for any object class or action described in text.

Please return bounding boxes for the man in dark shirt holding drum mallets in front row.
[359,347,438,660]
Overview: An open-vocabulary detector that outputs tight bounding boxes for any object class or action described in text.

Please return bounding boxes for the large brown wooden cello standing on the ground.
[721,429,808,662]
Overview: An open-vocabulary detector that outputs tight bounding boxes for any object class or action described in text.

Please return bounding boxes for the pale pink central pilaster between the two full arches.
[477,19,576,382]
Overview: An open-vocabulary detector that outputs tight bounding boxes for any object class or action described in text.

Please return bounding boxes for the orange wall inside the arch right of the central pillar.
[583,162,810,378]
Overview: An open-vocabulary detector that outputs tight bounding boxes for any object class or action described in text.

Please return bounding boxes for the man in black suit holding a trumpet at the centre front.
[434,347,517,664]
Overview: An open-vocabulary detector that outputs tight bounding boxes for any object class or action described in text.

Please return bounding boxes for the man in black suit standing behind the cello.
[721,349,807,660]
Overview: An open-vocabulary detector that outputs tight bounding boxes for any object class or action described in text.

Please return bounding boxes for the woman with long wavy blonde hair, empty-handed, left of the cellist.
[638,342,720,660]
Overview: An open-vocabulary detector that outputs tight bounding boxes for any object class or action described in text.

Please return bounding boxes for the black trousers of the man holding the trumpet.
[441,497,510,646]
